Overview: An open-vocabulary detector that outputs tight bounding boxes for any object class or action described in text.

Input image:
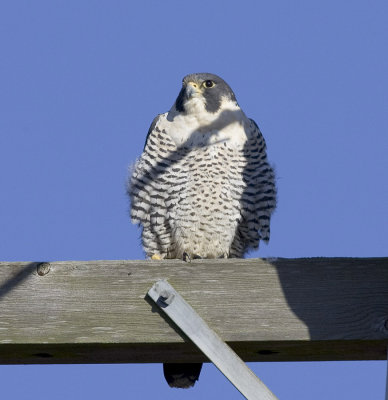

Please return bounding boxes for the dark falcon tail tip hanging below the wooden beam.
[163,363,202,389]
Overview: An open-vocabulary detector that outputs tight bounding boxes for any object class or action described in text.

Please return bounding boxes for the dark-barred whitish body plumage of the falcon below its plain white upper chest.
[128,113,276,258]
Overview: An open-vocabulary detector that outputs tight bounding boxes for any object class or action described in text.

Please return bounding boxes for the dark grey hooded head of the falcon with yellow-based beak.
[175,73,237,114]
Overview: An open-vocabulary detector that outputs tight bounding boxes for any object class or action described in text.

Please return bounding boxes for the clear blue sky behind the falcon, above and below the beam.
[0,0,388,400]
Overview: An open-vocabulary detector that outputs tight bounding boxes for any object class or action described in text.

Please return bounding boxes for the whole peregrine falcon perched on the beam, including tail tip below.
[128,73,276,387]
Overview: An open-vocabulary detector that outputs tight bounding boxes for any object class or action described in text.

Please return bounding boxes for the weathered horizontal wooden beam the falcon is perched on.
[0,258,388,364]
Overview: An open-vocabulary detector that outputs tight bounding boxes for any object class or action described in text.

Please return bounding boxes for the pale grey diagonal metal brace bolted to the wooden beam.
[148,280,277,400]
